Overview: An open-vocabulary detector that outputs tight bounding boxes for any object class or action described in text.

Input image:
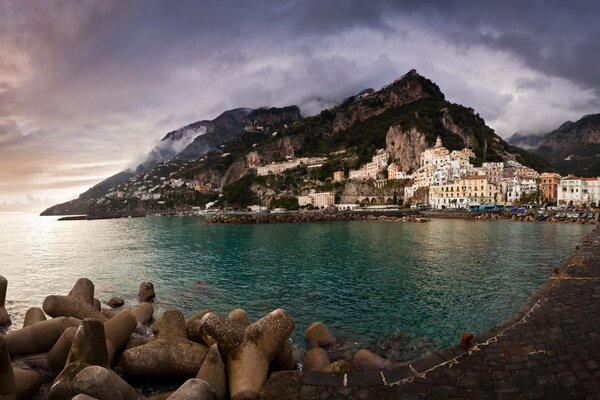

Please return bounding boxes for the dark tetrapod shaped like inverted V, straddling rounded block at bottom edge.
[48,318,139,400]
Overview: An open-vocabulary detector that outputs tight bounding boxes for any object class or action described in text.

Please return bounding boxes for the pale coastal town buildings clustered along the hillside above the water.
[97,136,600,219]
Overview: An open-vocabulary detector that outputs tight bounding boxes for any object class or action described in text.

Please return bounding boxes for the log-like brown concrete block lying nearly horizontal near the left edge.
[5,317,79,355]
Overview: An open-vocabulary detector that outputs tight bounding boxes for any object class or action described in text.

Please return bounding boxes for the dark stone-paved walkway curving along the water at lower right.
[261,228,600,400]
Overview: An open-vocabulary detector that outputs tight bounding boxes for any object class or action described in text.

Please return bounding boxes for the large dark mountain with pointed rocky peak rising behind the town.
[45,70,552,216]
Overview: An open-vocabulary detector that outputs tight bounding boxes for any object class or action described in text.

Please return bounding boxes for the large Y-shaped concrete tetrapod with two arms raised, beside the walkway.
[193,309,294,400]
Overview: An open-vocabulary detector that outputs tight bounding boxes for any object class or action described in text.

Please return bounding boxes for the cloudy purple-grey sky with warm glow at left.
[0,0,600,212]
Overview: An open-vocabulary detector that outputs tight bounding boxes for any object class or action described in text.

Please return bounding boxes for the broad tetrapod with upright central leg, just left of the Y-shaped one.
[122,310,208,377]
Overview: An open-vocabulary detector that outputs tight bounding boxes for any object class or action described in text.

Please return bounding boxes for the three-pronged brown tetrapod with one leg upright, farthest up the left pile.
[42,278,106,322]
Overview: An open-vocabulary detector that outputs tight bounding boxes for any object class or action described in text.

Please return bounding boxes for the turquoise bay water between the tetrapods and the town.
[0,215,591,360]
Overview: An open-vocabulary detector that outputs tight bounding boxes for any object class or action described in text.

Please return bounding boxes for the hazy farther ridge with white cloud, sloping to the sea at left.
[41,106,302,215]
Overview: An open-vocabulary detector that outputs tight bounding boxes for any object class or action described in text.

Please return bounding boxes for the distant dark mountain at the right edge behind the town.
[508,114,600,177]
